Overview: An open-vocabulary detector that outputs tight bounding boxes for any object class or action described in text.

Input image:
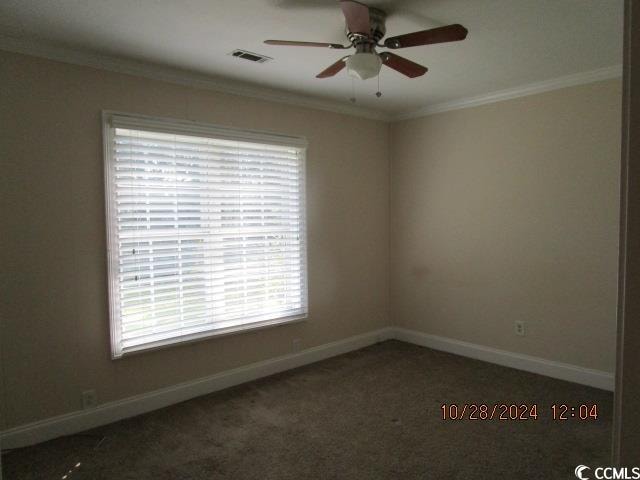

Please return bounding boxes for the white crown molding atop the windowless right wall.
[391,65,622,121]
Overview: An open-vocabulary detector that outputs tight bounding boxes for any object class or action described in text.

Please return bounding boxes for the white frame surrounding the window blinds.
[102,110,309,360]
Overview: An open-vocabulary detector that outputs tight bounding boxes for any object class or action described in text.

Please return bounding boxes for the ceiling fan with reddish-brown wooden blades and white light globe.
[264,0,467,80]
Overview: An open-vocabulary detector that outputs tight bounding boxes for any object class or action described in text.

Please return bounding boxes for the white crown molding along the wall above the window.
[0,35,390,121]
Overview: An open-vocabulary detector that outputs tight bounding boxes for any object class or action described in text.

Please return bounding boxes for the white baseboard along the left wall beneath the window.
[0,327,394,449]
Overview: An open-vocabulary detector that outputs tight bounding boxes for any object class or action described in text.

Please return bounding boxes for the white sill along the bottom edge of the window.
[111,314,308,360]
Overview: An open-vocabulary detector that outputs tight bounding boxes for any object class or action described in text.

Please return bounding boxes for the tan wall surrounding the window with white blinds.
[0,52,389,429]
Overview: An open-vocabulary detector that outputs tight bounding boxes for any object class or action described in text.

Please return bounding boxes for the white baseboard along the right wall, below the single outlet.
[394,327,615,391]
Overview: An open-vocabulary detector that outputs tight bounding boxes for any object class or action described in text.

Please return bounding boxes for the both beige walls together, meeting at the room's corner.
[0,47,620,429]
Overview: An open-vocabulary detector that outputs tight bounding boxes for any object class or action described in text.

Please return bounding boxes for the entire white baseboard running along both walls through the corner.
[0,327,614,449]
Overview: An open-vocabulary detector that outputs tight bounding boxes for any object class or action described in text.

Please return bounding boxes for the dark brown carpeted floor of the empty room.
[2,341,612,480]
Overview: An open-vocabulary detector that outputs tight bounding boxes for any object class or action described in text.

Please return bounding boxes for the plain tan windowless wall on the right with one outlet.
[391,80,621,372]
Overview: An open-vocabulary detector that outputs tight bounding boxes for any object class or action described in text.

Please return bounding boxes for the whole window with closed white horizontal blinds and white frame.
[103,113,307,358]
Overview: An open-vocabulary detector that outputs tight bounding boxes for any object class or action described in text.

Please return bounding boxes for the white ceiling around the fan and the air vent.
[0,0,623,115]
